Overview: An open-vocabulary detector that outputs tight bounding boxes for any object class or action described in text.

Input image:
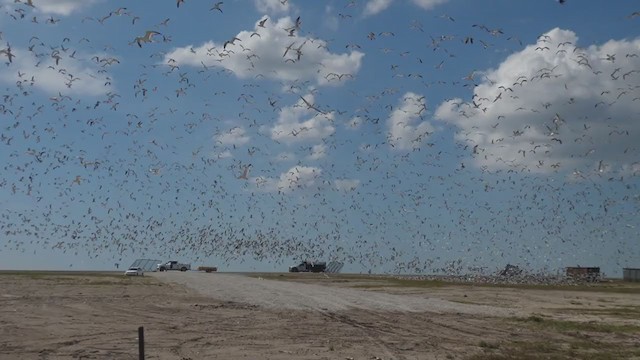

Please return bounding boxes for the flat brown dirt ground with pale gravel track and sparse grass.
[0,271,640,360]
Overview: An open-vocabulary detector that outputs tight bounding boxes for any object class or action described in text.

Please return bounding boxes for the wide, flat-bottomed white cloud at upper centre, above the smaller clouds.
[164,17,364,86]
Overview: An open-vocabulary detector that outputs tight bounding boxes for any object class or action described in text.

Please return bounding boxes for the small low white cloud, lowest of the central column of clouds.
[251,166,322,193]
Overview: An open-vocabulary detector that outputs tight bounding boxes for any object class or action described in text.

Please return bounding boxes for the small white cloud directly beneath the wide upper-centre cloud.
[269,94,335,144]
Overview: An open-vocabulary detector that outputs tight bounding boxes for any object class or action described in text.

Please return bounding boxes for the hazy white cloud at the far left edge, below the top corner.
[0,48,113,96]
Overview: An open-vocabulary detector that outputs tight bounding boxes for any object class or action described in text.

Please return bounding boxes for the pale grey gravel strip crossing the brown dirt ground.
[150,272,513,316]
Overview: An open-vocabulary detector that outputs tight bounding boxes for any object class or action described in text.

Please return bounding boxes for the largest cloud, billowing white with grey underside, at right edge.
[435,28,640,175]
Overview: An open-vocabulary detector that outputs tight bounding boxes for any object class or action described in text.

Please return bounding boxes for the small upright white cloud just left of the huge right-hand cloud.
[387,92,435,150]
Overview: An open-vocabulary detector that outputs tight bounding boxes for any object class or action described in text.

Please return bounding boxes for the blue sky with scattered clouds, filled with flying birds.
[0,0,640,275]
